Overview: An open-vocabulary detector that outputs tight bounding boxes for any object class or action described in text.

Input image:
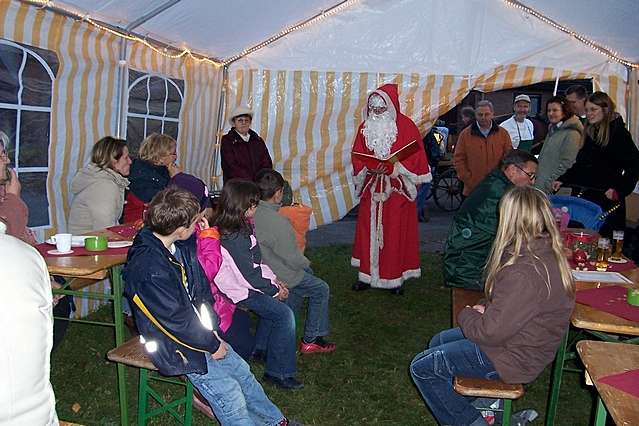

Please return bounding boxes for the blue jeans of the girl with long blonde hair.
[410,327,499,426]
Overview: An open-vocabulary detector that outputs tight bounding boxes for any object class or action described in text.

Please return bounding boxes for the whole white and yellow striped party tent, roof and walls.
[0,0,639,314]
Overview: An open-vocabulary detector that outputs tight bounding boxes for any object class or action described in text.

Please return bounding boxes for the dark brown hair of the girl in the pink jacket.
[215,179,260,235]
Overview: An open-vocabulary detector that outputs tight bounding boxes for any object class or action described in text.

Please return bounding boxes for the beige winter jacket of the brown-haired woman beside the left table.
[68,163,129,235]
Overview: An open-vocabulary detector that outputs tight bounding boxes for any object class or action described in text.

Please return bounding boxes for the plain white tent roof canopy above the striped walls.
[50,0,639,67]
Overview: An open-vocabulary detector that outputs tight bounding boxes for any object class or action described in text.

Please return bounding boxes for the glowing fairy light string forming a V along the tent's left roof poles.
[27,0,361,67]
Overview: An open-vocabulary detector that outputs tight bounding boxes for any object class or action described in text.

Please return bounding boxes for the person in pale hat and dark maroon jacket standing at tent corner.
[221,106,273,182]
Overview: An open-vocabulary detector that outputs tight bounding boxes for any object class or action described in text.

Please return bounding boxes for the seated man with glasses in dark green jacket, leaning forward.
[444,149,537,290]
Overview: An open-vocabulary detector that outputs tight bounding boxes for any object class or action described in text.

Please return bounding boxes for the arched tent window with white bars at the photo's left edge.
[0,39,58,227]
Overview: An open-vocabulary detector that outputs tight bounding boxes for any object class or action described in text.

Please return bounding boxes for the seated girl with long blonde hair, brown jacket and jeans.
[410,187,575,426]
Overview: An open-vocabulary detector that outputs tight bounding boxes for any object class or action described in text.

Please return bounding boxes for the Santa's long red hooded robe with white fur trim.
[351,84,431,289]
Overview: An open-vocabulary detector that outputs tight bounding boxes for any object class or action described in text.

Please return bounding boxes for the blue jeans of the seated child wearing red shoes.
[286,272,330,342]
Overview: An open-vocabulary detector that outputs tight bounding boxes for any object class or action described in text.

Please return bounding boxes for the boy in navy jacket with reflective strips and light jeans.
[124,188,288,425]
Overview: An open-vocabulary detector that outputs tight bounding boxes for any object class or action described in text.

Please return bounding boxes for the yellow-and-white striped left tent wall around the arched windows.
[0,1,222,317]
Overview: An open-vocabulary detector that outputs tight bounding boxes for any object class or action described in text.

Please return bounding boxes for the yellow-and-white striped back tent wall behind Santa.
[226,64,626,228]
